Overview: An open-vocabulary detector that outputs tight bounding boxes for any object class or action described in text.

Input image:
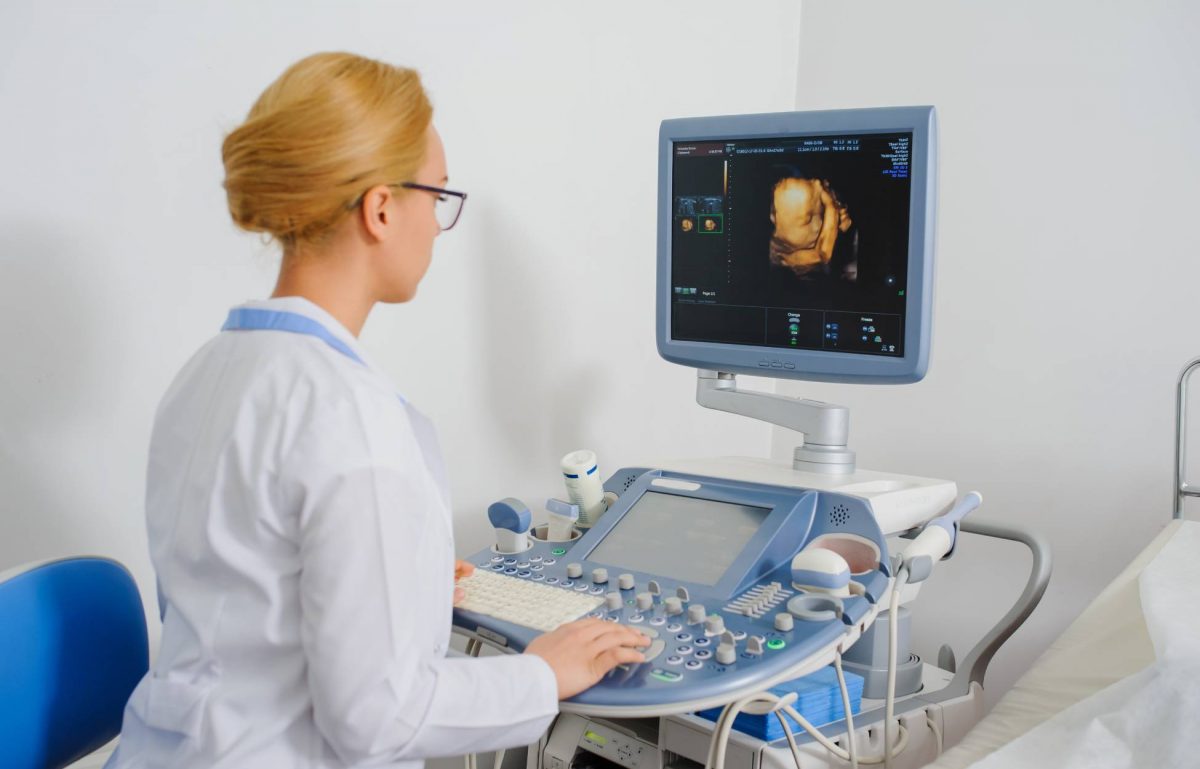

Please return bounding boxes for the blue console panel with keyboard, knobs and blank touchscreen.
[454,468,892,716]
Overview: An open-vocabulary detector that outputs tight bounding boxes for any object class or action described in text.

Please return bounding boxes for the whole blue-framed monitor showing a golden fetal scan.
[658,107,936,384]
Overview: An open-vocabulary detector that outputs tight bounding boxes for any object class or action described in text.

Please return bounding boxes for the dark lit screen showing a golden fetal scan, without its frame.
[671,132,912,356]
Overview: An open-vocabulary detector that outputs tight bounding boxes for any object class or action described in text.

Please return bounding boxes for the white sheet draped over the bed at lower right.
[950,523,1200,769]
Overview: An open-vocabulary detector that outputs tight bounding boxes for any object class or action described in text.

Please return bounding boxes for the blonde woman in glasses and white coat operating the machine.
[109,54,647,769]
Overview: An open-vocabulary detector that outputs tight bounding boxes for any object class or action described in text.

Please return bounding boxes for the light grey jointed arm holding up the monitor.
[696,368,854,475]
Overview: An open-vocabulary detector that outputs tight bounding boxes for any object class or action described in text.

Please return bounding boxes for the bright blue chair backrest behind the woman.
[0,558,149,769]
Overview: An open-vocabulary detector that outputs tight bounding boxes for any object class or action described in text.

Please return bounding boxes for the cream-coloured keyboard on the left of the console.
[456,569,604,632]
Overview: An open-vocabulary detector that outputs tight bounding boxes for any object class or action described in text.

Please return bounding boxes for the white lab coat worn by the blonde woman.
[108,298,558,769]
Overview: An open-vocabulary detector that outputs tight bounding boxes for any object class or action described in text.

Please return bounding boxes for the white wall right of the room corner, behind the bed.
[774,0,1200,698]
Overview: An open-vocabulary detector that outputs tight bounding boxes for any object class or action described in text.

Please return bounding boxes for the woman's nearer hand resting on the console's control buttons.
[524,619,650,699]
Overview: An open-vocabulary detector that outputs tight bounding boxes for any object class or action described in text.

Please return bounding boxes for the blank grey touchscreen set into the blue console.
[588,492,770,585]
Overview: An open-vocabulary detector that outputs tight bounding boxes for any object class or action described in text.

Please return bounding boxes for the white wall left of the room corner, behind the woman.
[0,0,799,636]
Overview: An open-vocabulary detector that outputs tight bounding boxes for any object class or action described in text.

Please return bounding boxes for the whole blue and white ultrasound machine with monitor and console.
[454,107,1038,769]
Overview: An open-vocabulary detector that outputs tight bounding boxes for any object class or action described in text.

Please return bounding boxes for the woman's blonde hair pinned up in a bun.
[221,53,433,250]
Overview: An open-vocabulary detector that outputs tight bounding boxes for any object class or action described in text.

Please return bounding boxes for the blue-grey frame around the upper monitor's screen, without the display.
[656,107,937,384]
